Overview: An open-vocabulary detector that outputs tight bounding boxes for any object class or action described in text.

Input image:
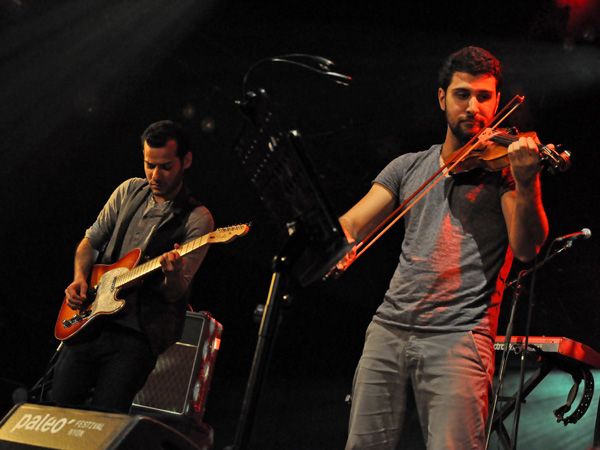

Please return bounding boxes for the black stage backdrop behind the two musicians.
[0,0,600,449]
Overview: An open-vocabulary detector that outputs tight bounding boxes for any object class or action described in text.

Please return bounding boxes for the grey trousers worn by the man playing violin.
[346,322,494,450]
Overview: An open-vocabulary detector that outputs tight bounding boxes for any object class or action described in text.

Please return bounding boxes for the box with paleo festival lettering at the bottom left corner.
[0,403,207,450]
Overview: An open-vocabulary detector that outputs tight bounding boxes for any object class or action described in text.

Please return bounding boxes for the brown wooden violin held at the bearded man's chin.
[444,128,571,174]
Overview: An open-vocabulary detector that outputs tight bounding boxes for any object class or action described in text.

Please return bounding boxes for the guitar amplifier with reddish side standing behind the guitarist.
[131,312,223,420]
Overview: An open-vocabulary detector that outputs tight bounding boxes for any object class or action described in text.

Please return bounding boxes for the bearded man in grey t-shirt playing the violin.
[339,47,548,450]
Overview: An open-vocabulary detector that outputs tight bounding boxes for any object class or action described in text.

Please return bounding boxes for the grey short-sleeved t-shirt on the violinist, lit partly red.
[374,145,514,336]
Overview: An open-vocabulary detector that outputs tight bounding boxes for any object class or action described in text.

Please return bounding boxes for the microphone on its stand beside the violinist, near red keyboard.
[485,238,573,450]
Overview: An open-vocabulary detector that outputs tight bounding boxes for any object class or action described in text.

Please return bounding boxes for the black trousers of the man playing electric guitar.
[51,323,157,413]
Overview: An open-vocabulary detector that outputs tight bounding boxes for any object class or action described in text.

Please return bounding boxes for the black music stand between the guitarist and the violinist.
[228,89,352,450]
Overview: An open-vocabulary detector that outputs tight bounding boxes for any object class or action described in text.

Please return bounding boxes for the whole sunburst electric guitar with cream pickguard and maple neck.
[54,225,250,341]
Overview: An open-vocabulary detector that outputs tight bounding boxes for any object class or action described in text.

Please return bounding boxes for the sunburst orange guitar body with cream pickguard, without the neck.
[54,248,142,341]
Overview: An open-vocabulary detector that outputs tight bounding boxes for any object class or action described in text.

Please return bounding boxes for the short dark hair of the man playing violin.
[438,47,502,92]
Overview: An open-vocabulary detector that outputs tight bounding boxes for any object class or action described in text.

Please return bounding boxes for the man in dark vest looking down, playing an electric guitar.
[52,121,214,413]
